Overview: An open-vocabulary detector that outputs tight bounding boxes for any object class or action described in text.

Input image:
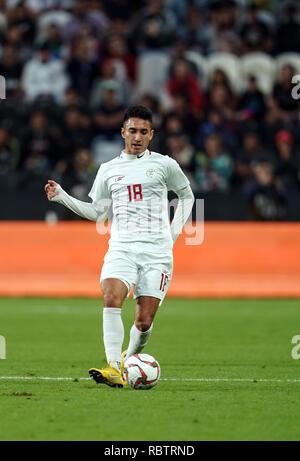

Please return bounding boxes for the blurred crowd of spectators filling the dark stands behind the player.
[0,0,300,220]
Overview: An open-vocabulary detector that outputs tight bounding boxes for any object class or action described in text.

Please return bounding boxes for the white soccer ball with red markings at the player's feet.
[124,354,160,389]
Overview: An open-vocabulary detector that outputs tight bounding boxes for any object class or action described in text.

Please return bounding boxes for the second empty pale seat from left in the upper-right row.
[241,52,276,95]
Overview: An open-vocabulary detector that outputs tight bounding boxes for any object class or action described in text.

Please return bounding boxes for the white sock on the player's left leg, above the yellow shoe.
[103,307,124,370]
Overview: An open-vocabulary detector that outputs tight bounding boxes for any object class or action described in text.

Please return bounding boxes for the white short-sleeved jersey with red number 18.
[89,149,189,255]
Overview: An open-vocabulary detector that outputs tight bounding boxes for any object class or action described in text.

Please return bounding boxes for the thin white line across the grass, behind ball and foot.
[0,376,300,383]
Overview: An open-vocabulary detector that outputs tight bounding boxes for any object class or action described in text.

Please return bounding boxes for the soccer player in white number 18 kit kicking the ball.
[45,106,194,387]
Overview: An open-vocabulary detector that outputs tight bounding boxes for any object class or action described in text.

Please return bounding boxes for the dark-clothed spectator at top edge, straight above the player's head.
[130,0,176,52]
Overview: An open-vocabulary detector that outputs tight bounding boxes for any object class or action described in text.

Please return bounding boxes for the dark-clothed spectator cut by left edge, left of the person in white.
[0,44,22,99]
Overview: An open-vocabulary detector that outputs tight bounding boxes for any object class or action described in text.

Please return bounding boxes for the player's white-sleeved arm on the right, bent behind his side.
[171,186,195,243]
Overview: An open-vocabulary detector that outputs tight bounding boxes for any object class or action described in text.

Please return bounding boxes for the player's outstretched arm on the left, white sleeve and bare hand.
[45,179,108,221]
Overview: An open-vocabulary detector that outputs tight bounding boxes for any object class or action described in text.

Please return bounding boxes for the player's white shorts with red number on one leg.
[100,250,173,305]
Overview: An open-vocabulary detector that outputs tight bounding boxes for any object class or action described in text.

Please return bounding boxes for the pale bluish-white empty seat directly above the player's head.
[137,52,170,97]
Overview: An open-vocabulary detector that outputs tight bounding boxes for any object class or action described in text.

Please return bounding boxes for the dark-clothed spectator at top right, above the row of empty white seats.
[240,3,273,53]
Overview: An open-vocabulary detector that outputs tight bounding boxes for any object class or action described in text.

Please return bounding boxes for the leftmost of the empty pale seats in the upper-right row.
[207,52,243,93]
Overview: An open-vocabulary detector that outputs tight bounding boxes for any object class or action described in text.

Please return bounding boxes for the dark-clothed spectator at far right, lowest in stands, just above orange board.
[246,161,287,221]
